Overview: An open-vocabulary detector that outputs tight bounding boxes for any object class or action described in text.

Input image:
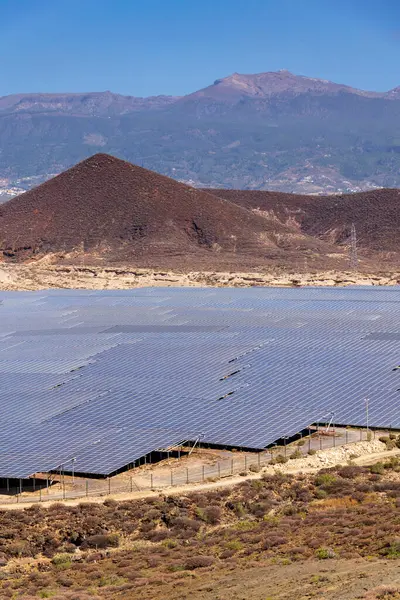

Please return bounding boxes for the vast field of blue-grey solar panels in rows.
[0,287,400,477]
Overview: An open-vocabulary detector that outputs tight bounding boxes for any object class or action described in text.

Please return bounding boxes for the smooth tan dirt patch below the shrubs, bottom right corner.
[155,559,400,600]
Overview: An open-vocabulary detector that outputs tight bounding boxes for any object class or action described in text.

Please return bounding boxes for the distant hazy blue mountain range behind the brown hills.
[0,71,400,201]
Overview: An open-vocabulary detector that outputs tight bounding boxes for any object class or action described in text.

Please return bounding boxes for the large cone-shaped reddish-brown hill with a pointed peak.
[0,154,330,269]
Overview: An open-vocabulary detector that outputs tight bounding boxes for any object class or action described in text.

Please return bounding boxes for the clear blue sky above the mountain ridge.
[0,0,400,96]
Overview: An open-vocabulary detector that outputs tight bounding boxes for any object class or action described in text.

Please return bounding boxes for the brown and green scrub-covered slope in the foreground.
[0,458,400,600]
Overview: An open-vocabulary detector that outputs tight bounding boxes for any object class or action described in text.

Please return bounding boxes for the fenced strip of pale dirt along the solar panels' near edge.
[0,428,384,505]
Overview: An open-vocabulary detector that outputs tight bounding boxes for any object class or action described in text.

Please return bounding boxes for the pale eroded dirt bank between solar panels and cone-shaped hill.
[0,257,400,290]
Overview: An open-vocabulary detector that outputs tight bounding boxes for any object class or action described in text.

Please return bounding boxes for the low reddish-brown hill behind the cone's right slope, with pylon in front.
[209,189,400,252]
